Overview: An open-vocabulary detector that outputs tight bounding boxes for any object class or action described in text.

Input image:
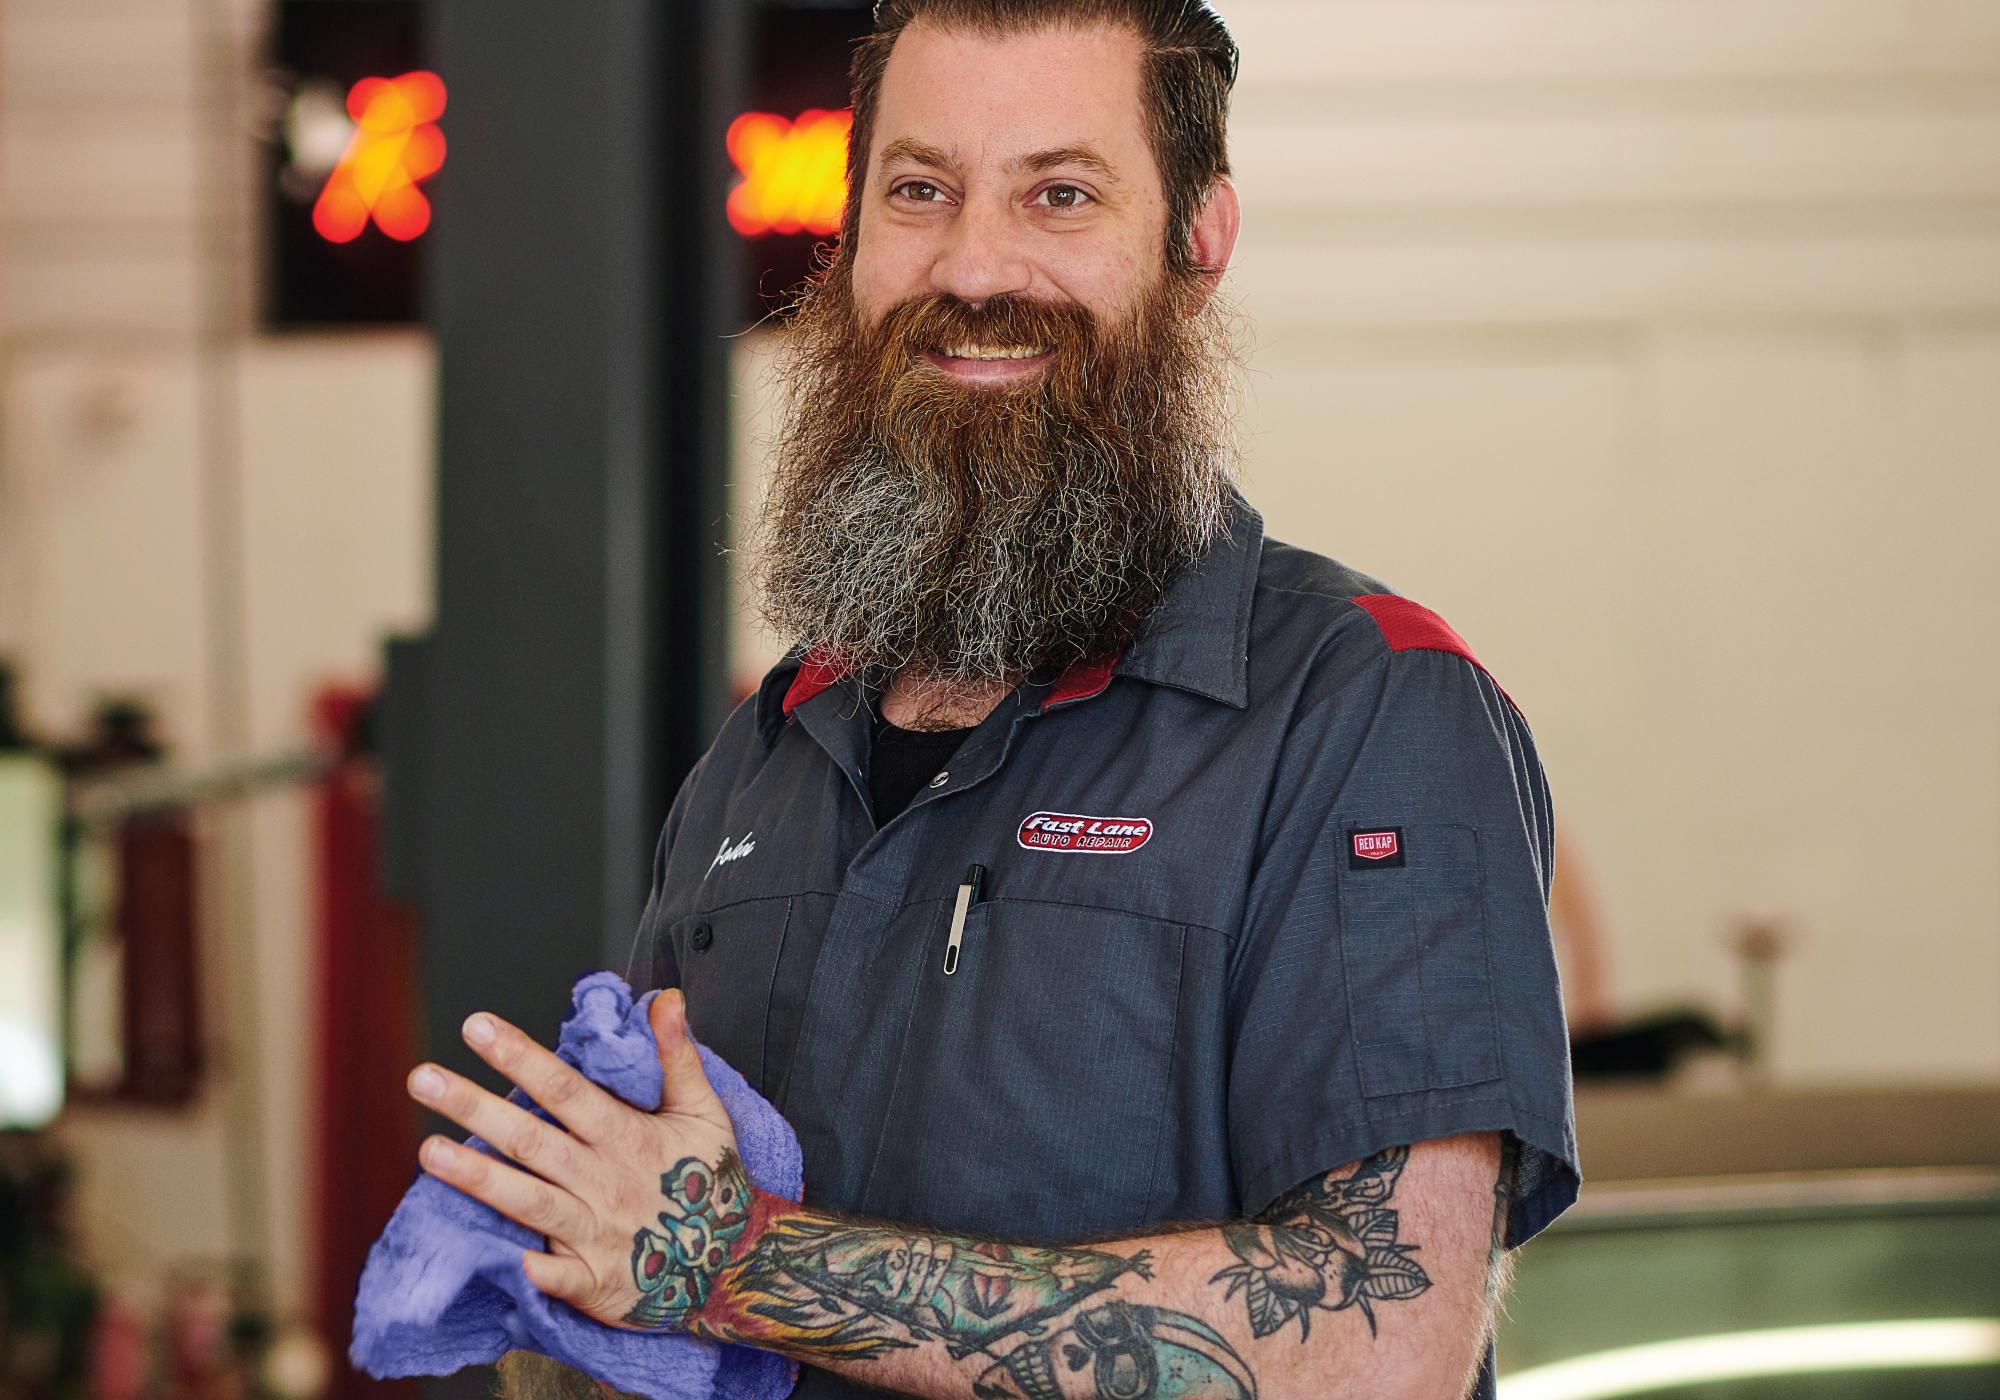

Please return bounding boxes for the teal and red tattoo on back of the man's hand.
[624,1152,750,1328]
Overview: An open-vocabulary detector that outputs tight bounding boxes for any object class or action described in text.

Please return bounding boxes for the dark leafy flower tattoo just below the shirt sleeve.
[1210,1148,1430,1342]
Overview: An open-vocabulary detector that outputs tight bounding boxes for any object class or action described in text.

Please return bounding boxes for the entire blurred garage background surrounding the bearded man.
[0,0,2000,1400]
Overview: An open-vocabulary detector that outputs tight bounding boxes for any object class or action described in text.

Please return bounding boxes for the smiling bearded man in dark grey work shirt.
[412,0,1576,1400]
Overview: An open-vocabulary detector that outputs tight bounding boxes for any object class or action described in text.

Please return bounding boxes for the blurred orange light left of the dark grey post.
[312,72,444,244]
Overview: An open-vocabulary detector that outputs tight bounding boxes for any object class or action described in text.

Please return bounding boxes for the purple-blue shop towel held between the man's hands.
[348,972,804,1400]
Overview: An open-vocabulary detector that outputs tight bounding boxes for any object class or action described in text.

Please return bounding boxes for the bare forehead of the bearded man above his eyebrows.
[870,20,1152,180]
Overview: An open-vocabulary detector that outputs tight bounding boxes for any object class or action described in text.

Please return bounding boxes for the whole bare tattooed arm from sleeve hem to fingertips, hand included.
[412,996,1506,1400]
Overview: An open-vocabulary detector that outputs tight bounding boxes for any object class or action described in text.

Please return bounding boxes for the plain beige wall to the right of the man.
[1224,0,2000,1082]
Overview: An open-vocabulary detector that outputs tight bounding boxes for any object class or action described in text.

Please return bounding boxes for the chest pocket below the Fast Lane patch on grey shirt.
[862,900,1188,1238]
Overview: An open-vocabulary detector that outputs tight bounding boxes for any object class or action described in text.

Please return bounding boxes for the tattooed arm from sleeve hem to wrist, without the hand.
[672,1134,1500,1400]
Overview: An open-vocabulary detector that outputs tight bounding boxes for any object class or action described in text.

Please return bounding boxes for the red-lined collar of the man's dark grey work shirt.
[756,492,1264,744]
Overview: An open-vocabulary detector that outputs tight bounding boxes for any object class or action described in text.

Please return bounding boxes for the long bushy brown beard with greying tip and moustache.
[752,260,1232,694]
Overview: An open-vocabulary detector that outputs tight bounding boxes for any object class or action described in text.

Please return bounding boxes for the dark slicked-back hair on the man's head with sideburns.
[840,0,1236,270]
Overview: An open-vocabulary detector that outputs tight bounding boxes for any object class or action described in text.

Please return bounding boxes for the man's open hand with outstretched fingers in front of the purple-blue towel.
[410,990,740,1326]
